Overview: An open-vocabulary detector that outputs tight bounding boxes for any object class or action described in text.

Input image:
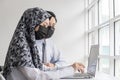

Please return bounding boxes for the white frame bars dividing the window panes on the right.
[85,0,120,76]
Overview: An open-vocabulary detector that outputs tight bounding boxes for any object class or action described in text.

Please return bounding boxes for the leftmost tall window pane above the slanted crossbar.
[89,4,98,29]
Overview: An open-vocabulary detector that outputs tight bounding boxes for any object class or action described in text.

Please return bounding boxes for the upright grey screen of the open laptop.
[87,45,99,76]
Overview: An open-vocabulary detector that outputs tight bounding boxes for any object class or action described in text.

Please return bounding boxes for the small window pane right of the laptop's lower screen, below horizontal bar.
[99,58,110,74]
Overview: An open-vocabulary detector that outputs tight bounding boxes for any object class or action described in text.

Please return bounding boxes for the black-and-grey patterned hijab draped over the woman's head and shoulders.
[3,7,51,78]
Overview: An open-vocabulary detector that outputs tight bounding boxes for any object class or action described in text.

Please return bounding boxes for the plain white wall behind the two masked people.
[0,0,85,65]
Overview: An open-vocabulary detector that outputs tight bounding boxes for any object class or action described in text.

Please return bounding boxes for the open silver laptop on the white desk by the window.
[60,45,99,79]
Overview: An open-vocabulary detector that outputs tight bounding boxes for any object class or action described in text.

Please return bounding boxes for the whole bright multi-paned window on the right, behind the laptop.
[86,0,120,79]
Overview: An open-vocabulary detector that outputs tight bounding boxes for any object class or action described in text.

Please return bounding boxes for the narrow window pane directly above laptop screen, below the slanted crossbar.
[89,31,98,51]
